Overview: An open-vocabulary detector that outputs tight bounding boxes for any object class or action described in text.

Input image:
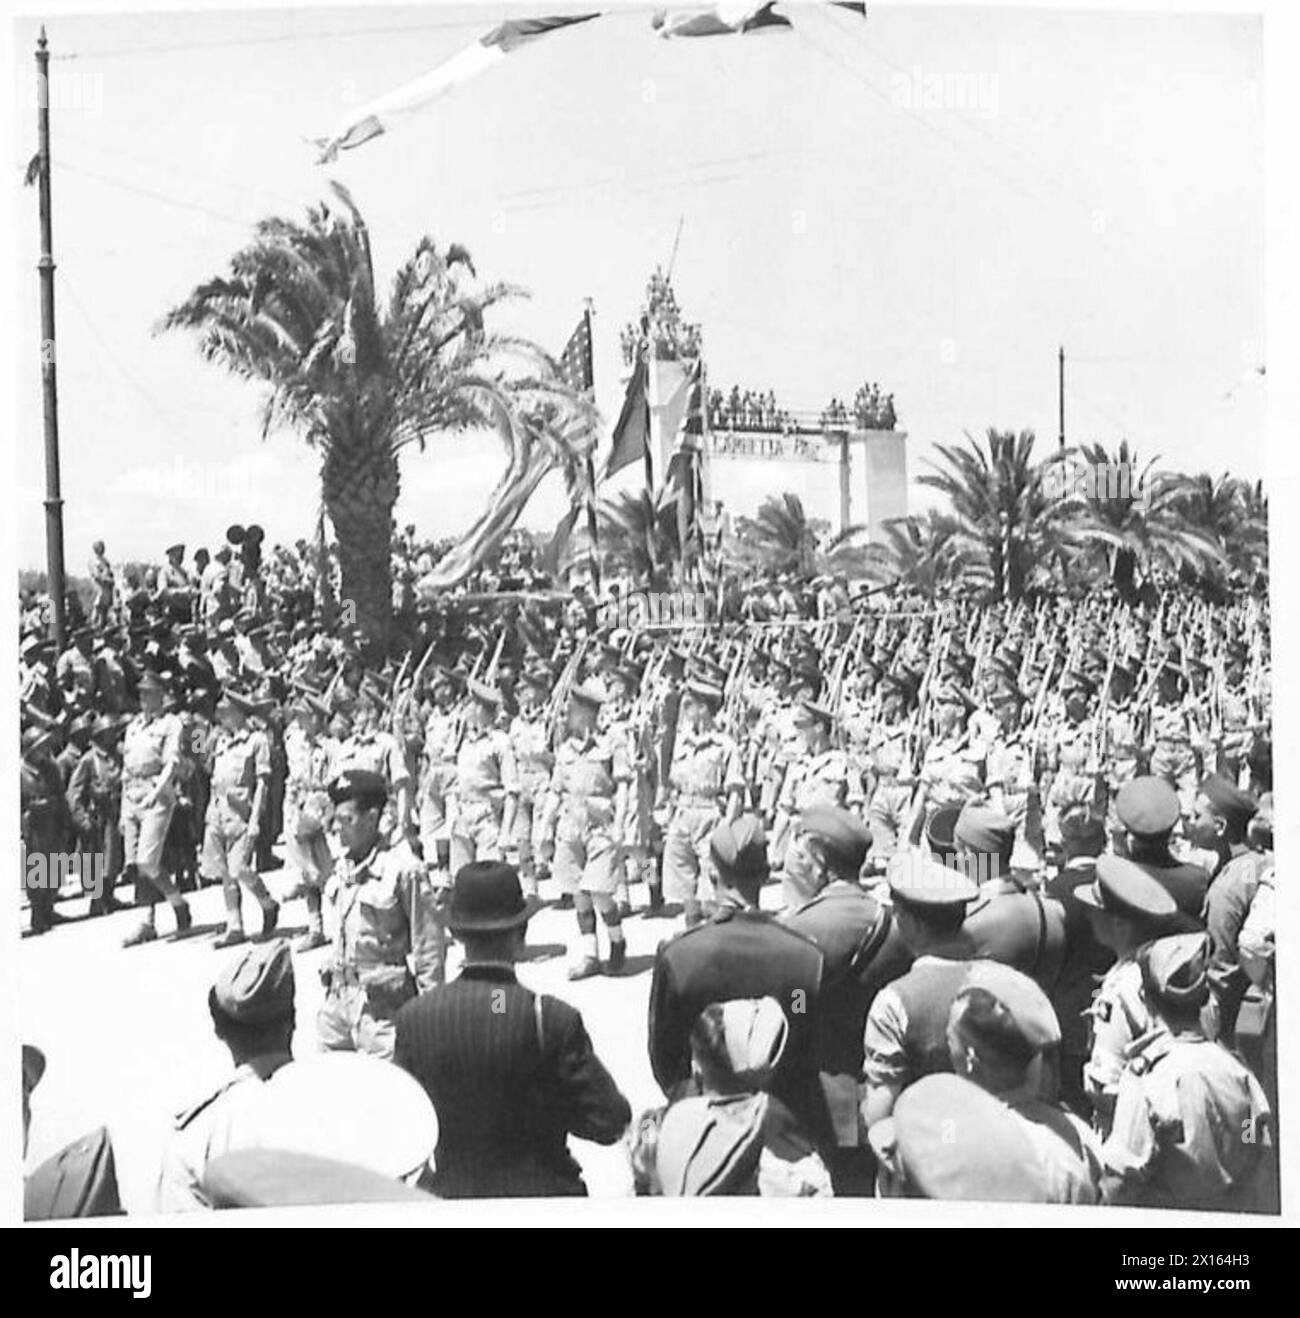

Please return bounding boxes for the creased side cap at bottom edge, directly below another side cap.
[655,1094,766,1198]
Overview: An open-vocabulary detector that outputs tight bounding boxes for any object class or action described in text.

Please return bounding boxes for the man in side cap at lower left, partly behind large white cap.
[156,938,294,1213]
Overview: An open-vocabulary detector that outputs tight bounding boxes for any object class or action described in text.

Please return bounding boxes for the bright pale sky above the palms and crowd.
[12,4,1266,572]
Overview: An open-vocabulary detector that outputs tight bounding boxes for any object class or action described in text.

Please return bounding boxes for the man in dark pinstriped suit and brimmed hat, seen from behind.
[393,861,632,1198]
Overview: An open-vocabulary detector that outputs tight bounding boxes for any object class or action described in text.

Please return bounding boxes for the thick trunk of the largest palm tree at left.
[320,444,398,650]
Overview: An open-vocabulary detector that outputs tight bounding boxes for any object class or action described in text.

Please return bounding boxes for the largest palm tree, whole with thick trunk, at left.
[158,183,593,643]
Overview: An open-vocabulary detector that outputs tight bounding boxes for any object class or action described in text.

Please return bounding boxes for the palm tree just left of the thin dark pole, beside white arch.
[918,427,1104,600]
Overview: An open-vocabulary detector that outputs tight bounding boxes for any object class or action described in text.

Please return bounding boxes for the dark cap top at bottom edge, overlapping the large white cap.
[203,1149,438,1209]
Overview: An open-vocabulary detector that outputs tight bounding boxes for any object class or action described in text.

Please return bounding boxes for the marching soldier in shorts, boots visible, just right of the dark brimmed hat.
[542,687,632,979]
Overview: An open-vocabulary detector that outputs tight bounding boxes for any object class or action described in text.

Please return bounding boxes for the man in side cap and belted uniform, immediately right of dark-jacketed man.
[782,807,912,1195]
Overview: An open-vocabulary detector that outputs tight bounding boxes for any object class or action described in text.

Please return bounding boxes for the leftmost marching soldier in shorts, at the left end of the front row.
[121,672,194,948]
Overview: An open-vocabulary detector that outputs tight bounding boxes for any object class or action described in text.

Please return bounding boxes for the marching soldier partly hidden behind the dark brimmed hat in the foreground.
[451,679,519,874]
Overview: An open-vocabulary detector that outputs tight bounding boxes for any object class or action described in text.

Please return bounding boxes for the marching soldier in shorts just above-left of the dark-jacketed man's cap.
[663,679,745,929]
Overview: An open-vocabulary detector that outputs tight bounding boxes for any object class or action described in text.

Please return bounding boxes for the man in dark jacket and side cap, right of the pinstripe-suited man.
[649,815,829,1143]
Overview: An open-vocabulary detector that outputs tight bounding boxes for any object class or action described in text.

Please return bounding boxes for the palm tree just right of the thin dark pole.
[1077,440,1231,600]
